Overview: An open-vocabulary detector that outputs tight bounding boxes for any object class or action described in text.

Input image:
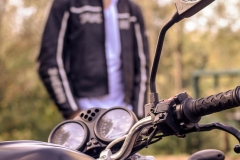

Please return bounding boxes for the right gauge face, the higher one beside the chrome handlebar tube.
[96,109,134,140]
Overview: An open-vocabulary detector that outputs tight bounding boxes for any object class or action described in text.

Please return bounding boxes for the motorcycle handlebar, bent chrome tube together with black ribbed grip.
[106,86,240,159]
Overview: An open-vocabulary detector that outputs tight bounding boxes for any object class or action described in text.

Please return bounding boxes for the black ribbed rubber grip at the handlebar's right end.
[182,86,240,123]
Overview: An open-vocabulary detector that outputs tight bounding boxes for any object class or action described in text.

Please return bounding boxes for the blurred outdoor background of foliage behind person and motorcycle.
[0,0,240,158]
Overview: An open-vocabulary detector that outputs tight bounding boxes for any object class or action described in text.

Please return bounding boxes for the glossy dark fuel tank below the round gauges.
[0,140,94,160]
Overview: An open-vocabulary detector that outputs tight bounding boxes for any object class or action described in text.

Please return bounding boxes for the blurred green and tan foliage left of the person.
[0,1,61,141]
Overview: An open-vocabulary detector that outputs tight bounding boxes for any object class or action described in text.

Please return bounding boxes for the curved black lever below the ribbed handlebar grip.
[198,122,240,153]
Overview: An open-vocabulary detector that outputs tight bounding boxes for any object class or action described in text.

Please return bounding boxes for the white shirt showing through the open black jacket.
[78,0,131,109]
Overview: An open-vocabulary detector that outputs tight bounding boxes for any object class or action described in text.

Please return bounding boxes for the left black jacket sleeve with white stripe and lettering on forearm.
[37,0,78,118]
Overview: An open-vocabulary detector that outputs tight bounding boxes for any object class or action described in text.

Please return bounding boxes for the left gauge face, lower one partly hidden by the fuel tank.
[50,122,86,150]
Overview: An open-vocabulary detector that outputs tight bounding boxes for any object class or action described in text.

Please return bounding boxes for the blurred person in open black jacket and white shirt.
[37,0,149,119]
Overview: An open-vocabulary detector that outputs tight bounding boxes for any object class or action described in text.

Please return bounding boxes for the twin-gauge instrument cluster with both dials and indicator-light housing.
[48,107,137,154]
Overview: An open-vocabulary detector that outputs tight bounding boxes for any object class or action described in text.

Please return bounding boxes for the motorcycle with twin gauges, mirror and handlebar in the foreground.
[0,0,240,160]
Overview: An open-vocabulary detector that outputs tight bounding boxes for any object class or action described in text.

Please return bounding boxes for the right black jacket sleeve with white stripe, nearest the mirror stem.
[133,1,149,118]
